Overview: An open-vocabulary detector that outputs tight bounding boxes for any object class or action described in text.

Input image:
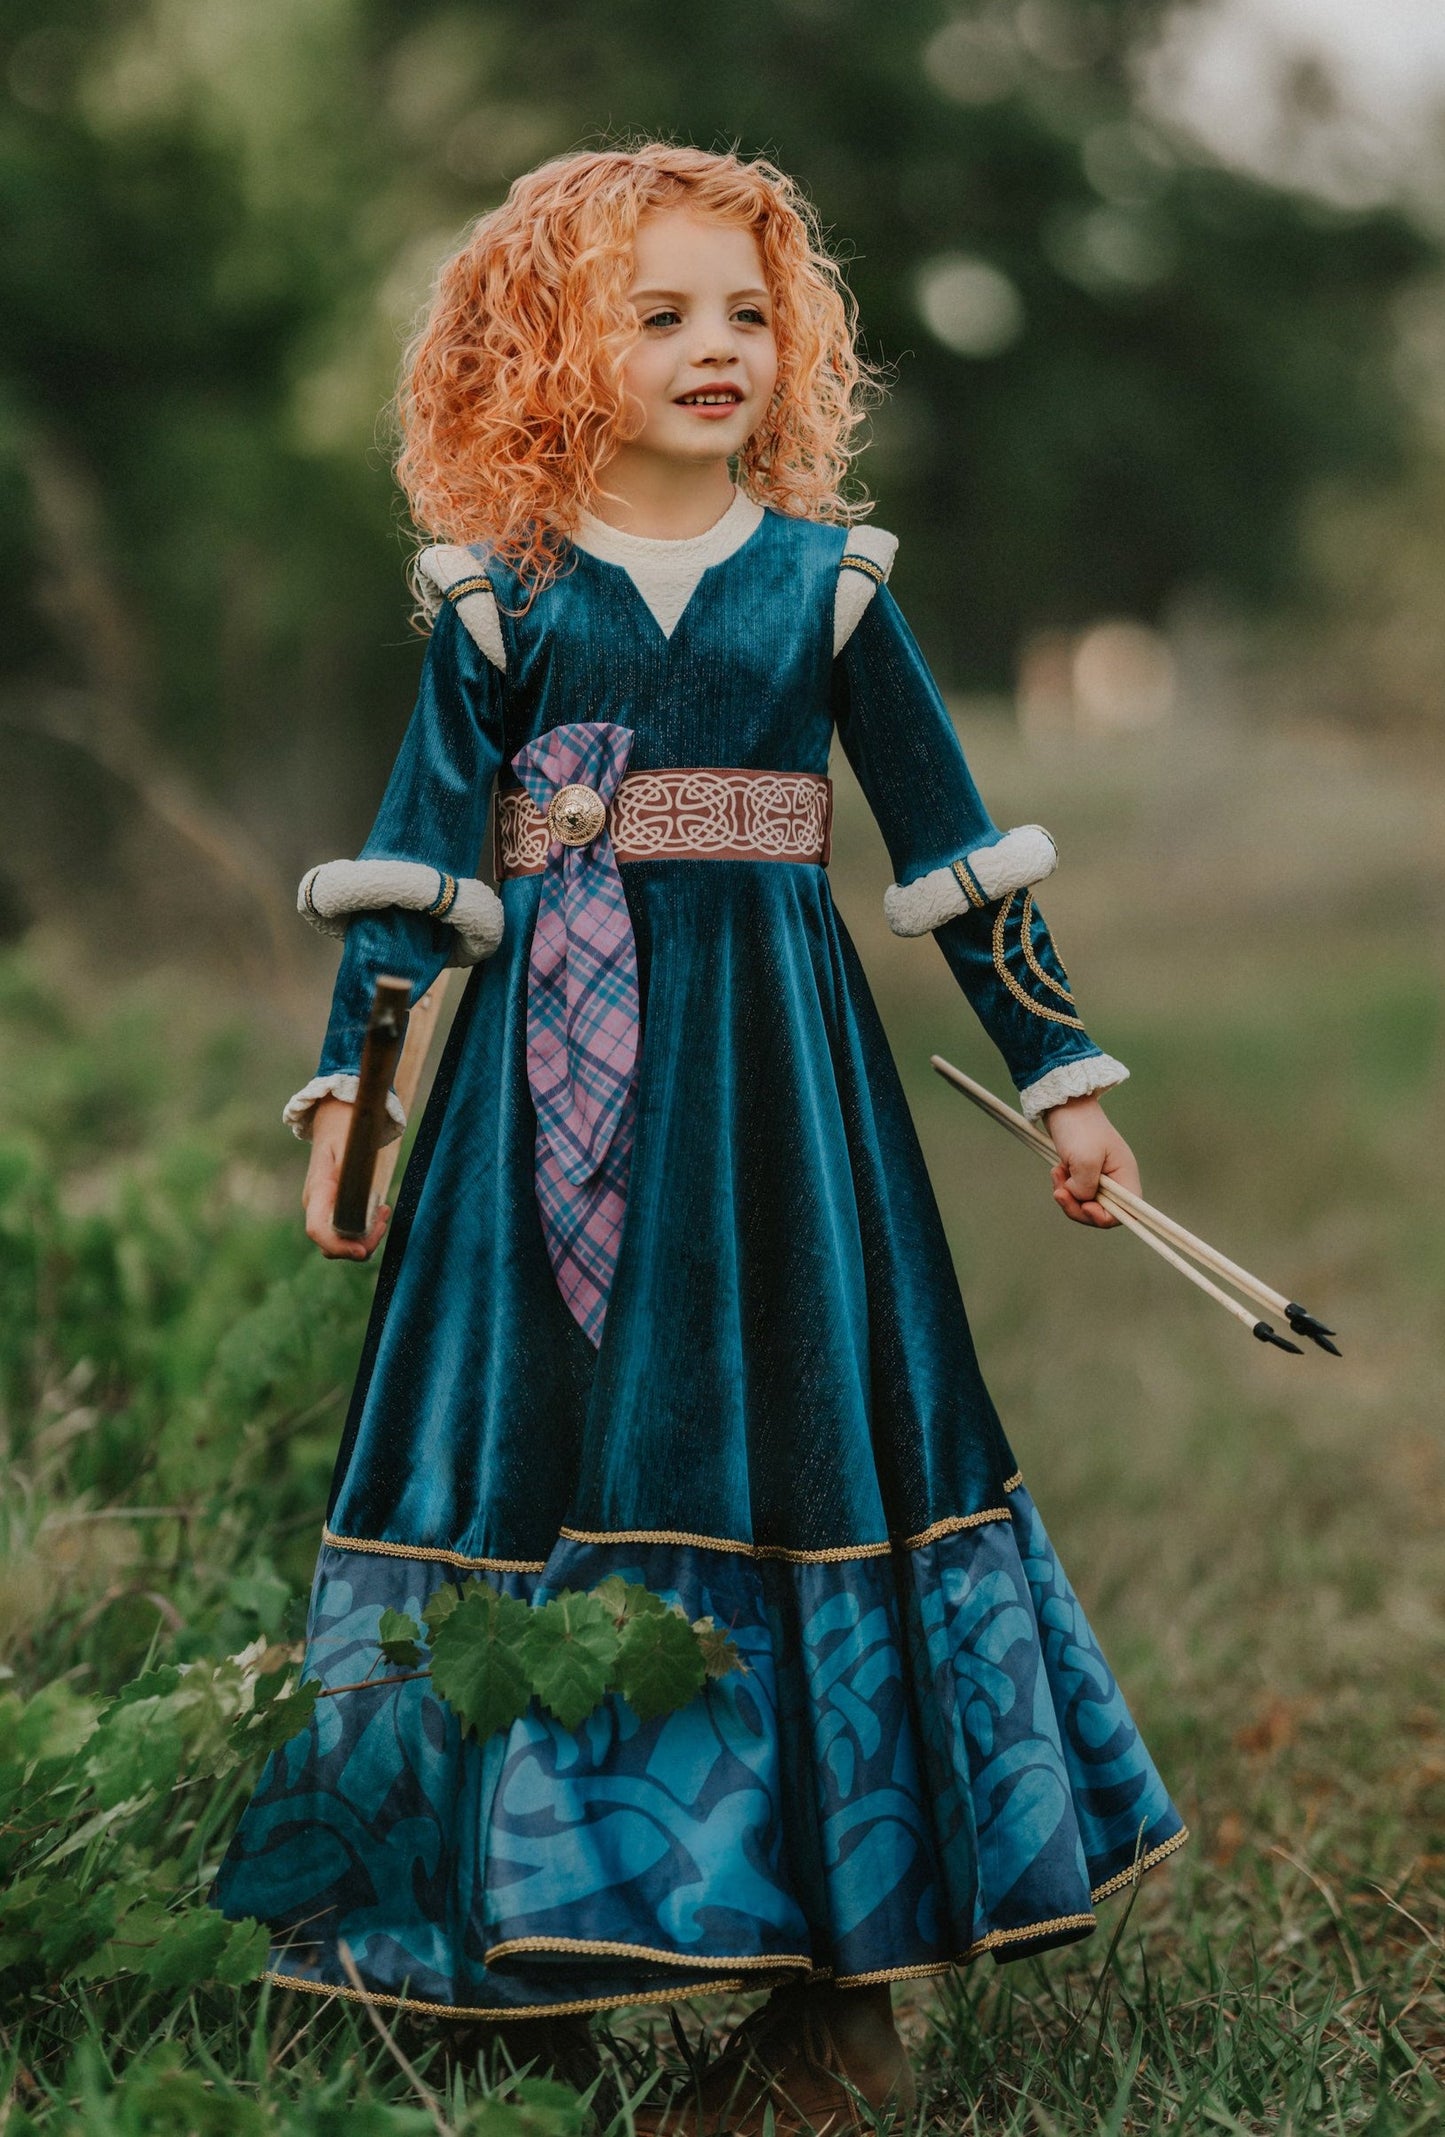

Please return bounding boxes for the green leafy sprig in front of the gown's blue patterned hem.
[354,1573,748,1737]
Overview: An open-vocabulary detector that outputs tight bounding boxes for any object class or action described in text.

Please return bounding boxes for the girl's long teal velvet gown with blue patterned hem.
[218,511,1186,2015]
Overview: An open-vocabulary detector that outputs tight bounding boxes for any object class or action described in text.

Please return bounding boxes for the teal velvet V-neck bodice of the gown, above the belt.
[485,500,846,774]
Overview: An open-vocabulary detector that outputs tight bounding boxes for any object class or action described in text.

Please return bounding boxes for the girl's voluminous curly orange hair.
[395,141,872,588]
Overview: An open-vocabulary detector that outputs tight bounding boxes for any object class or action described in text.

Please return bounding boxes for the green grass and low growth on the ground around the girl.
[0,718,1445,2137]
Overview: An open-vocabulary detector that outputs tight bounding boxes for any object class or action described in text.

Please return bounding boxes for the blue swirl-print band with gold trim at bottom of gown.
[218,1485,1186,2015]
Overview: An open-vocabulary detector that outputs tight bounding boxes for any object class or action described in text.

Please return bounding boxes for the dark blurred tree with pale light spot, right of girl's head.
[455,0,1432,684]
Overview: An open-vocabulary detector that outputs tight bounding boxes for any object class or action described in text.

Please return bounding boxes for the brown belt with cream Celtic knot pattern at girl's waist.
[492,765,834,883]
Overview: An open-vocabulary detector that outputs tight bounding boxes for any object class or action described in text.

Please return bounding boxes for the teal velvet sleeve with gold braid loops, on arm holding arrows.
[834,588,1129,1116]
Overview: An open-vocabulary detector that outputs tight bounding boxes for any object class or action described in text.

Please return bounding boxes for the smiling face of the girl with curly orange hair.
[624,209,778,464]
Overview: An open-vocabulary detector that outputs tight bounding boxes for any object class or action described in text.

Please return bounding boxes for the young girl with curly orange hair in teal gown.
[220,145,1186,2133]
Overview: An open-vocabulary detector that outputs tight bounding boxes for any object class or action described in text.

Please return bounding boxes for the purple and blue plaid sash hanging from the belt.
[511,720,641,1344]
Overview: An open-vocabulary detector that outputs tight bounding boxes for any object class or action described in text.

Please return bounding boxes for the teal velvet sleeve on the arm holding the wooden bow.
[286,603,502,1135]
